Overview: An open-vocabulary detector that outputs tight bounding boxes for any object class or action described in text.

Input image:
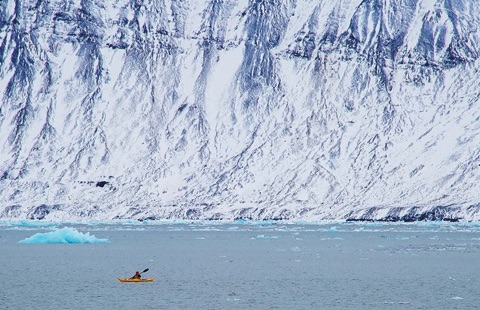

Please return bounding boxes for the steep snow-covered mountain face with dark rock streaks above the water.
[0,0,480,221]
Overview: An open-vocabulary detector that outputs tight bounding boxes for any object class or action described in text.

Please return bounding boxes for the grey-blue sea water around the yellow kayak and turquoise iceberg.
[0,222,480,309]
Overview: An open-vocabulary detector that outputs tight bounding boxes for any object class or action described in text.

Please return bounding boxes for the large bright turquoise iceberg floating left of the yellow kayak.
[19,227,110,244]
